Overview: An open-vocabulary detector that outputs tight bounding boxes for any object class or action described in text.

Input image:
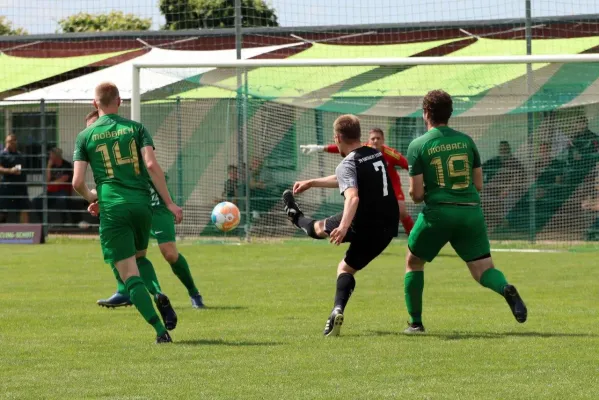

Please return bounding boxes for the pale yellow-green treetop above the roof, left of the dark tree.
[58,11,152,33]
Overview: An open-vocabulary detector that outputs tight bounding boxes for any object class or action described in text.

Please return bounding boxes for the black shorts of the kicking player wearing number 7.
[324,213,395,271]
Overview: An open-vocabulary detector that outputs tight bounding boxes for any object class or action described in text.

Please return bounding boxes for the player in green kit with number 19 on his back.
[405,90,527,333]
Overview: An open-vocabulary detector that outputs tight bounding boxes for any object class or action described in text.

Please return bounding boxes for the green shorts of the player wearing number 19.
[408,205,491,262]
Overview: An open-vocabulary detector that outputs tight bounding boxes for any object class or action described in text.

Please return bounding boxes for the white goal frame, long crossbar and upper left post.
[131,54,599,121]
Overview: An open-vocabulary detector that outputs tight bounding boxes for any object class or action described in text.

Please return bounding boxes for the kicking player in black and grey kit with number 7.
[283,115,399,336]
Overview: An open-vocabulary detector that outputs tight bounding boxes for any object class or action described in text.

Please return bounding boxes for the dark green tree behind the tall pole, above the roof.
[160,0,279,30]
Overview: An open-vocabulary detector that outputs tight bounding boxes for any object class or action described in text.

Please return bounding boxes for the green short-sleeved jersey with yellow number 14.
[73,114,154,207]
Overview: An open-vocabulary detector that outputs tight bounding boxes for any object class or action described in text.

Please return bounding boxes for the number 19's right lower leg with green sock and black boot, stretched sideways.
[467,254,528,323]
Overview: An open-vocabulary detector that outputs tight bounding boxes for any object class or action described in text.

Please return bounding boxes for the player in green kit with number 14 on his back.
[73,82,183,343]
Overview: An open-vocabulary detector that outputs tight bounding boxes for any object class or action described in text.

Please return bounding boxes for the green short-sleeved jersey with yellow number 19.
[408,126,481,205]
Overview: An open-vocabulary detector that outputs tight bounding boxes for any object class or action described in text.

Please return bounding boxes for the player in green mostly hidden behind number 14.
[85,110,204,308]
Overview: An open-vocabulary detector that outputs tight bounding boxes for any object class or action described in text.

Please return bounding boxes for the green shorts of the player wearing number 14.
[100,204,152,263]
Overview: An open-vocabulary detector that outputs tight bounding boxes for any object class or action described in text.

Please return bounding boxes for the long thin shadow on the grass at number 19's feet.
[368,331,599,340]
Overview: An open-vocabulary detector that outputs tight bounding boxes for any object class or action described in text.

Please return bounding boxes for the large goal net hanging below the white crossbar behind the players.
[132,52,599,242]
